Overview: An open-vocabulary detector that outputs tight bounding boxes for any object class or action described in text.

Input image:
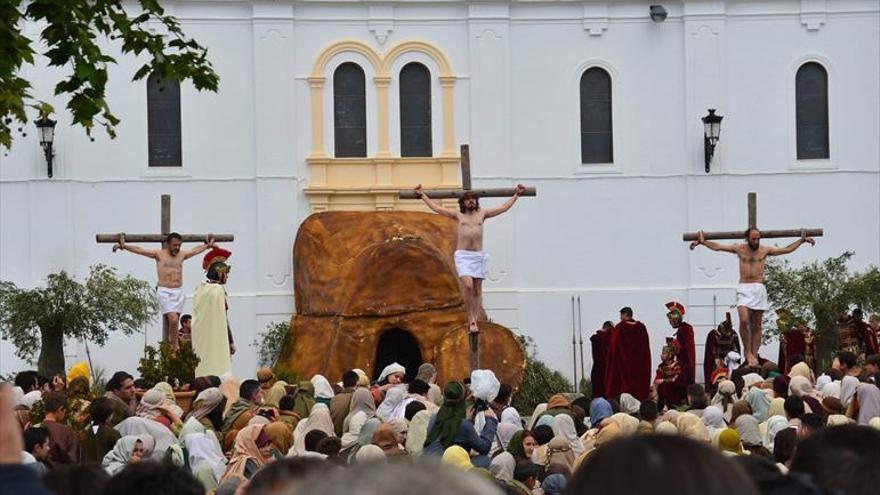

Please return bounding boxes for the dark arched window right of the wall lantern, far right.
[795,62,829,160]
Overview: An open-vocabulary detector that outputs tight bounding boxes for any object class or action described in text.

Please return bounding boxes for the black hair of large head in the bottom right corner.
[791,425,880,495]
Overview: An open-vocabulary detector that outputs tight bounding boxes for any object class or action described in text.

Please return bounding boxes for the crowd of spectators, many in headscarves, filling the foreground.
[0,356,880,495]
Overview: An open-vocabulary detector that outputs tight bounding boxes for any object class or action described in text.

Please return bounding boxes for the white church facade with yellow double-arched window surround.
[0,0,880,379]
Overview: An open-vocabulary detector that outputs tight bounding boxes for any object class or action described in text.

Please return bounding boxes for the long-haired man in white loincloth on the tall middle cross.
[415,184,526,333]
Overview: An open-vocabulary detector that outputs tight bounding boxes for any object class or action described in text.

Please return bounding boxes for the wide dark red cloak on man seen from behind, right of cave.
[605,321,653,401]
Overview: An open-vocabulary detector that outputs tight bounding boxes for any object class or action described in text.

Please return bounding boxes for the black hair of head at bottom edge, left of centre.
[103,462,205,495]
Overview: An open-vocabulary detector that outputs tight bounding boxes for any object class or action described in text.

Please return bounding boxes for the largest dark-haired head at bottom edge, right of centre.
[565,435,760,495]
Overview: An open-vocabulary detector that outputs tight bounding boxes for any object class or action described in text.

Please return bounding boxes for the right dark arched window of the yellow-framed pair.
[400,62,433,156]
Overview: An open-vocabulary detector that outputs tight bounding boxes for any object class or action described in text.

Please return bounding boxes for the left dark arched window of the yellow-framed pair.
[333,62,367,158]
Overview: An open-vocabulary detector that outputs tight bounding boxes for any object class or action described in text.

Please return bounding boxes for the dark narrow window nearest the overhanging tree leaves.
[147,73,183,167]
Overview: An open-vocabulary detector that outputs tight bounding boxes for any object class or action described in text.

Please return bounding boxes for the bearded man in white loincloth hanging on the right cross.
[691,227,816,366]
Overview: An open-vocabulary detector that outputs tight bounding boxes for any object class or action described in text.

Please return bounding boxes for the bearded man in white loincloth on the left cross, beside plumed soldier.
[113,232,216,352]
